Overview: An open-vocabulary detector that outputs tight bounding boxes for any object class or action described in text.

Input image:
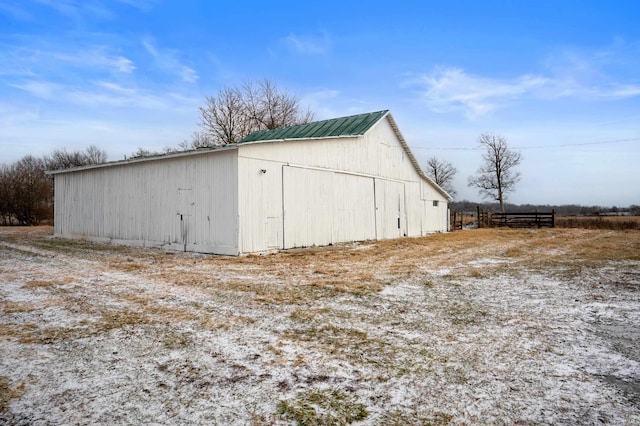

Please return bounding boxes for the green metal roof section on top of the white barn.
[238,110,389,143]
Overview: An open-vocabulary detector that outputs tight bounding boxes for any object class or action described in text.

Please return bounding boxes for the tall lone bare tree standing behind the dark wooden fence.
[469,133,522,212]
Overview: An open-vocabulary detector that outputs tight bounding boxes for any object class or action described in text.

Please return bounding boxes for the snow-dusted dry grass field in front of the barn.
[0,227,640,425]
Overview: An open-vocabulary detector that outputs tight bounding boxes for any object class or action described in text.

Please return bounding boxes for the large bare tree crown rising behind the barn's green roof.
[196,79,313,148]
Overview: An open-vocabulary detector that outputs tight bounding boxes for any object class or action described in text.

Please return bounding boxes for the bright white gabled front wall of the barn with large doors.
[238,115,448,252]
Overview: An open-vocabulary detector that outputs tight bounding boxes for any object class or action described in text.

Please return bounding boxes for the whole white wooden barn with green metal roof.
[51,111,449,255]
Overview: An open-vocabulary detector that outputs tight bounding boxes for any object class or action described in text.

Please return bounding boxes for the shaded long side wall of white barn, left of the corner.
[54,150,238,254]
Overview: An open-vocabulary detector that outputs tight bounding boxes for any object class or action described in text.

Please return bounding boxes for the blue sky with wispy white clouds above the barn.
[0,0,640,206]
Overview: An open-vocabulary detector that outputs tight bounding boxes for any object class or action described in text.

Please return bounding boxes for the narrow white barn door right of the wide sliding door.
[375,179,407,240]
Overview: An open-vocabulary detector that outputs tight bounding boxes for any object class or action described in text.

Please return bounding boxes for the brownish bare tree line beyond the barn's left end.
[0,145,107,226]
